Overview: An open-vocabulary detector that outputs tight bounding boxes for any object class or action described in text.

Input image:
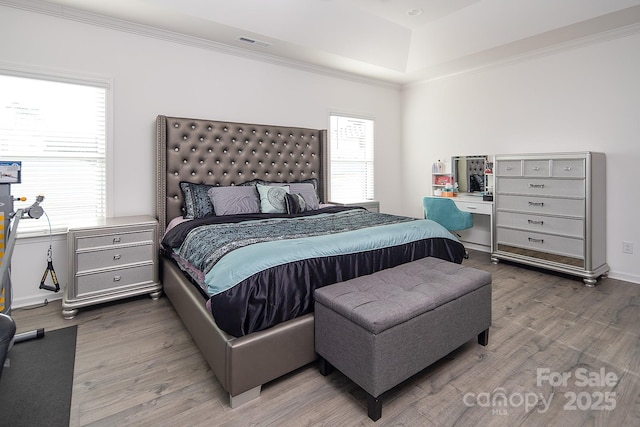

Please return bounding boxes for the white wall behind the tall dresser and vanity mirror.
[402,34,640,283]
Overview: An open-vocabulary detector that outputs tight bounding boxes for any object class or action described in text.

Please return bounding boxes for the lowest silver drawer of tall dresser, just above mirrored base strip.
[496,227,584,258]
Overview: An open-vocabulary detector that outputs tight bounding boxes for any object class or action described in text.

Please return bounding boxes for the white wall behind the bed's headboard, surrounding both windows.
[0,7,402,307]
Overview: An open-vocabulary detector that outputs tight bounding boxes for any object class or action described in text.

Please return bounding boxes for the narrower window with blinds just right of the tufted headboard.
[329,114,374,202]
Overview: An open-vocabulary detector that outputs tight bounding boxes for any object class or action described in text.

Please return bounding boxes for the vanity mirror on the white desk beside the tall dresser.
[451,155,493,196]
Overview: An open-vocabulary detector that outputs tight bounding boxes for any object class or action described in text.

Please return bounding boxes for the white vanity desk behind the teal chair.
[452,193,493,252]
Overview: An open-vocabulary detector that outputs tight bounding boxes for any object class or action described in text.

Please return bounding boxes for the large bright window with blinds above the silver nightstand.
[0,70,108,234]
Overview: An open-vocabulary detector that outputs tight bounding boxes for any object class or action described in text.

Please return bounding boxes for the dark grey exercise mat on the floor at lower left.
[0,326,77,427]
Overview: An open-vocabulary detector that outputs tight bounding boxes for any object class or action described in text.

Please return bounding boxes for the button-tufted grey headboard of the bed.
[156,115,328,235]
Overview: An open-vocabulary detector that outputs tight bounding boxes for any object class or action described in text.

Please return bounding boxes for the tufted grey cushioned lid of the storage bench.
[315,257,491,334]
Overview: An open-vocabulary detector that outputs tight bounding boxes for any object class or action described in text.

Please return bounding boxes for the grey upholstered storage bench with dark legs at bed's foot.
[315,258,491,421]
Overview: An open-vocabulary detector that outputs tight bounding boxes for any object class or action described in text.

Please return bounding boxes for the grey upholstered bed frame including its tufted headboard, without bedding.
[156,116,328,408]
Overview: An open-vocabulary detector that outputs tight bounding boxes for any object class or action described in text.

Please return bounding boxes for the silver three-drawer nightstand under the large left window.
[62,216,162,319]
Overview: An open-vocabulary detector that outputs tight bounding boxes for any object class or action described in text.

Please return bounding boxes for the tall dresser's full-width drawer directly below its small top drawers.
[496,178,585,197]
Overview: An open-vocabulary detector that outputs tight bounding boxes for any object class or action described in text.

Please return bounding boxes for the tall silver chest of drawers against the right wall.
[491,152,609,286]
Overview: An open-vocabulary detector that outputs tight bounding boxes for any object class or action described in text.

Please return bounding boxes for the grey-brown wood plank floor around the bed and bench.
[13,251,640,426]
